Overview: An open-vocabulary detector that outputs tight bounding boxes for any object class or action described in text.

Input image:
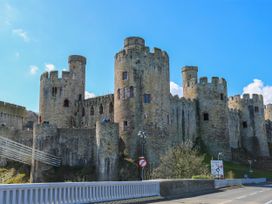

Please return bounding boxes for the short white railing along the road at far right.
[214,178,266,188]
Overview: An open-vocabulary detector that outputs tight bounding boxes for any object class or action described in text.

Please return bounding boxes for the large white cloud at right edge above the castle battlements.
[243,79,272,104]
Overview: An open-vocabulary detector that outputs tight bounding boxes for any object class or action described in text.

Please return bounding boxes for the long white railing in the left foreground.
[0,181,160,204]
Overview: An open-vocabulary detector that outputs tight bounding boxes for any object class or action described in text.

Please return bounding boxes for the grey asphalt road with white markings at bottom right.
[152,184,272,204]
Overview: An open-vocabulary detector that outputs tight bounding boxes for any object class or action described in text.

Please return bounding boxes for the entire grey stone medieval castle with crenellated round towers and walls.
[0,37,272,182]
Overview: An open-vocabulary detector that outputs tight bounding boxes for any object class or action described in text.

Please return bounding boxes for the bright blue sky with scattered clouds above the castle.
[0,0,272,111]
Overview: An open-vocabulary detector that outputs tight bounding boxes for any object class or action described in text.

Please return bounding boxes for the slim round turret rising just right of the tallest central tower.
[182,66,198,99]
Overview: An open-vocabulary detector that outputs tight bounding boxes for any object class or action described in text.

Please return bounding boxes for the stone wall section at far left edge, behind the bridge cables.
[0,101,27,129]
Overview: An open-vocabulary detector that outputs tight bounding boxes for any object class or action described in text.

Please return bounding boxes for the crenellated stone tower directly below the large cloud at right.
[228,94,269,156]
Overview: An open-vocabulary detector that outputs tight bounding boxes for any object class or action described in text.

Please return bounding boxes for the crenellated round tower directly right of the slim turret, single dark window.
[197,77,231,159]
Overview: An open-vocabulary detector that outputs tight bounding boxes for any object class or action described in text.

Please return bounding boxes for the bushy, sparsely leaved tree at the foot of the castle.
[152,142,209,179]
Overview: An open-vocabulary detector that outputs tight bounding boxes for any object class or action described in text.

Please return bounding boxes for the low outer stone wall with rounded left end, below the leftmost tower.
[31,124,96,182]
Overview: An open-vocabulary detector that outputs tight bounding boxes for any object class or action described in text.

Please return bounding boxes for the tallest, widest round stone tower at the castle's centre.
[114,37,170,161]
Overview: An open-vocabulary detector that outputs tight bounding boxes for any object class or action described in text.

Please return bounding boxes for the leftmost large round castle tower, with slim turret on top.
[39,55,86,128]
